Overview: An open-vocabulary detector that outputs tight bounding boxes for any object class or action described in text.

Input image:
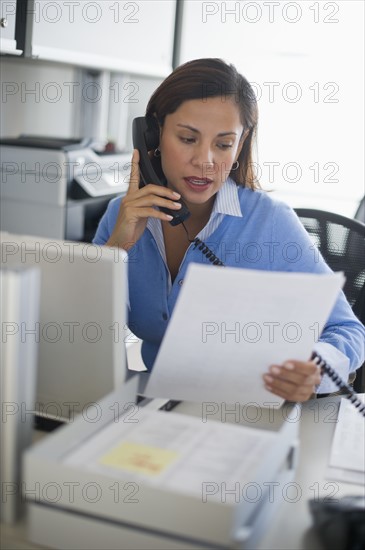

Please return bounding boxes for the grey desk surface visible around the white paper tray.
[1,397,364,550]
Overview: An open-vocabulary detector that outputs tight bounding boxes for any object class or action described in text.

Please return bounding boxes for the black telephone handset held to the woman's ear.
[132,116,190,225]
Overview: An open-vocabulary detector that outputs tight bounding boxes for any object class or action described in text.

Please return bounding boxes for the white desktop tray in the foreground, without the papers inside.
[23,384,301,550]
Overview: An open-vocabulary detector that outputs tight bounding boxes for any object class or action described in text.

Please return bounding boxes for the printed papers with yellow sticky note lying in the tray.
[64,409,279,500]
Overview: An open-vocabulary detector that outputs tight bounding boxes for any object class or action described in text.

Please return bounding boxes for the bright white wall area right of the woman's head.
[180,0,365,220]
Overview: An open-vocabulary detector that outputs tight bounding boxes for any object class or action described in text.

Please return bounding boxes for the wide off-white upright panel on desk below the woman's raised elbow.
[0,232,129,421]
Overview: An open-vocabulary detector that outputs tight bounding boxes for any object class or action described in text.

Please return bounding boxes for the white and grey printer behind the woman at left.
[0,135,131,242]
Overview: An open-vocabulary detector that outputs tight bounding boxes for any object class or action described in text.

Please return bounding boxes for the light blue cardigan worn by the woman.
[93,179,365,393]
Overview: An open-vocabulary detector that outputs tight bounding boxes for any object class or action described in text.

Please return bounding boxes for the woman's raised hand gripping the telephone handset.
[106,149,181,251]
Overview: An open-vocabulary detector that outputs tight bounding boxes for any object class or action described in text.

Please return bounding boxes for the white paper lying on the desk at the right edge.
[327,395,365,484]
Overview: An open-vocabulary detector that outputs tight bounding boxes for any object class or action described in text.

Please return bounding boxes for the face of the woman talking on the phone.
[160,97,243,205]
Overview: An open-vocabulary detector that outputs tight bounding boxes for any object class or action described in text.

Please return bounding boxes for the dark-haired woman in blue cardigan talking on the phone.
[94,59,365,401]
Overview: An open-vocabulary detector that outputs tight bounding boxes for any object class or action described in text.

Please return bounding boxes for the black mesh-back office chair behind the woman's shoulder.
[295,208,365,392]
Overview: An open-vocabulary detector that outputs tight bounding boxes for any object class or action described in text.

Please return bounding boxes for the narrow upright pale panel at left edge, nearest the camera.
[0,266,40,523]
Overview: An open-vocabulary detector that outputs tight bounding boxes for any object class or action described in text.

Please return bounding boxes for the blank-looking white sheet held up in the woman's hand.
[144,264,344,407]
